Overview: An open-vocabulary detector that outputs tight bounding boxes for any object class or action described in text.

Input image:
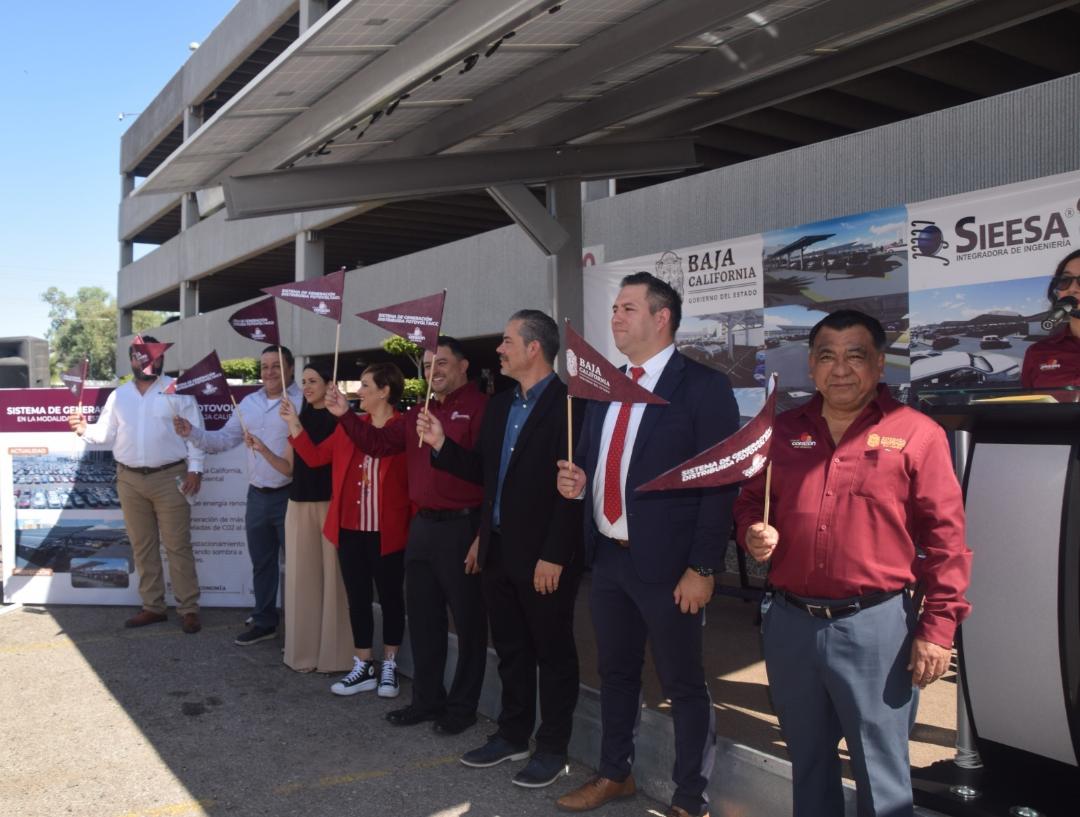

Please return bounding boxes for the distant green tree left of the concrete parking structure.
[41,286,165,380]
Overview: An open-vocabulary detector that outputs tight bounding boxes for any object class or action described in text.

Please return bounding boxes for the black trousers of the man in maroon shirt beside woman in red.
[405,515,487,719]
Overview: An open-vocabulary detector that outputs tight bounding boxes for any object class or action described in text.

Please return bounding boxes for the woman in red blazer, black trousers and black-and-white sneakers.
[281,363,410,698]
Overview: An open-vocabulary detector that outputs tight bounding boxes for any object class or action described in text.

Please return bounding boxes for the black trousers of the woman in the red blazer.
[338,528,405,649]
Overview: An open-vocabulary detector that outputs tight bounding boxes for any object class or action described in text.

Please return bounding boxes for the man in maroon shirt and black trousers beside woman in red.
[326,335,487,735]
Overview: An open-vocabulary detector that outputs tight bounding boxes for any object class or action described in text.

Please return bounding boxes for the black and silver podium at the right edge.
[916,389,1080,817]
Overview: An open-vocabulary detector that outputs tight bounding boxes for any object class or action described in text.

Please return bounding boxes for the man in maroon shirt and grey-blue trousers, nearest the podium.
[735,310,971,817]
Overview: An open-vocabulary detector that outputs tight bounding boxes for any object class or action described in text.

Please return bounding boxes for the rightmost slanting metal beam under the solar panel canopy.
[633,0,1072,138]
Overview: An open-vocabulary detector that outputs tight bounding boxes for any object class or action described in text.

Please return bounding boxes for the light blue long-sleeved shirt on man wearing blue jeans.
[188,383,303,488]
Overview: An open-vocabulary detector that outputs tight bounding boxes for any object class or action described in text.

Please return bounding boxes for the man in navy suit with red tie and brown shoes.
[557,272,739,817]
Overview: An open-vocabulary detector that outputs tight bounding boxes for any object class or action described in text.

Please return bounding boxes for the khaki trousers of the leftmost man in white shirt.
[117,463,199,615]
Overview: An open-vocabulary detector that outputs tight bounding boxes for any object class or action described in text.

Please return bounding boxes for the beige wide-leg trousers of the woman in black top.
[284,499,353,672]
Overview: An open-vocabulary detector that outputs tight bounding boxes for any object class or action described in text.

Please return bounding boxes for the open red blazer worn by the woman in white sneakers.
[288,412,413,555]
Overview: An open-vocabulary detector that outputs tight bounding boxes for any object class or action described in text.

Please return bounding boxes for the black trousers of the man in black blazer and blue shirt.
[481,534,581,756]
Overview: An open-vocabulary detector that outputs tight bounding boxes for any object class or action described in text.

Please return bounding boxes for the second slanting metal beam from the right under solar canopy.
[499,0,937,148]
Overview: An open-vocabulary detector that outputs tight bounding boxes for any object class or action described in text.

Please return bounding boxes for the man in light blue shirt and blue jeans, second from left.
[173,346,303,646]
